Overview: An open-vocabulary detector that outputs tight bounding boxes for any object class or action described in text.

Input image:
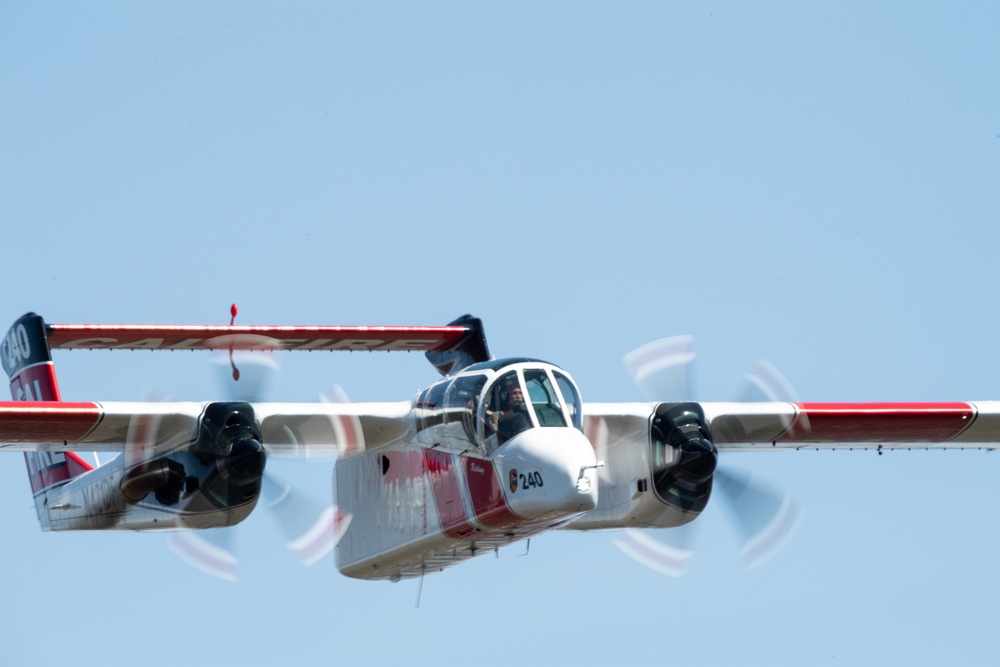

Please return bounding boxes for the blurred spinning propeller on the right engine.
[615,336,805,577]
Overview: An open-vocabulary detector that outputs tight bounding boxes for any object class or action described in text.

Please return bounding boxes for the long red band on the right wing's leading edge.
[778,402,976,442]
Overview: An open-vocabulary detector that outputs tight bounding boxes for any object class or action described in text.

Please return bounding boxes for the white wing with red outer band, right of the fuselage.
[584,401,1000,451]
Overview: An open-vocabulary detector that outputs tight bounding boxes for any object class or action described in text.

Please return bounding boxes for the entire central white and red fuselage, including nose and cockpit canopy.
[334,360,598,580]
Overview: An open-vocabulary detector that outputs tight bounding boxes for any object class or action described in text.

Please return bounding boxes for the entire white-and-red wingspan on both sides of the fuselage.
[7,401,1000,453]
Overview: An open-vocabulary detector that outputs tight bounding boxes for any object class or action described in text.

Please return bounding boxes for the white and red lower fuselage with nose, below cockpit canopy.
[335,429,597,580]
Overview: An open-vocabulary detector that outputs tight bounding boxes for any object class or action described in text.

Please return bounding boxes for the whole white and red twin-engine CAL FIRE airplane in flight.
[0,305,1000,581]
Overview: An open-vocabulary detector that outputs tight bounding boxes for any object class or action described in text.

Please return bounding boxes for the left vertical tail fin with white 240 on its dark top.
[0,313,92,530]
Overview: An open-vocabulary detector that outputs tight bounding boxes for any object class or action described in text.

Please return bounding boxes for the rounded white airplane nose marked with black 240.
[494,428,597,519]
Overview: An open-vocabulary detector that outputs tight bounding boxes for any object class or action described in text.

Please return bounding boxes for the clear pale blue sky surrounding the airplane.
[0,1,1000,665]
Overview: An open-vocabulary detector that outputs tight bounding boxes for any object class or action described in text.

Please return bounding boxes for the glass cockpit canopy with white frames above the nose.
[415,359,583,454]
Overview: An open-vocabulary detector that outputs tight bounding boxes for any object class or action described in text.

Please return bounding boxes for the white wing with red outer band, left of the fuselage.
[0,401,411,454]
